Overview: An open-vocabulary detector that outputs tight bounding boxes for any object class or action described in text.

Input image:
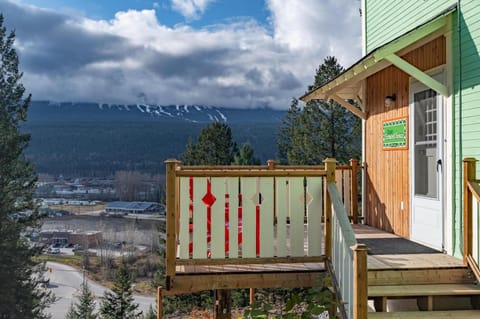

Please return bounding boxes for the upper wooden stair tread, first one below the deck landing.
[368,284,480,298]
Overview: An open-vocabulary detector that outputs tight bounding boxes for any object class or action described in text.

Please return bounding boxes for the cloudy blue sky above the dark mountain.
[0,0,361,109]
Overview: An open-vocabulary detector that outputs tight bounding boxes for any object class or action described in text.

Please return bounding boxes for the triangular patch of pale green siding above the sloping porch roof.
[365,0,457,52]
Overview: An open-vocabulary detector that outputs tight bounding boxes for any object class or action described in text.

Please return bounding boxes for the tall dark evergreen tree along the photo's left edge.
[0,15,53,318]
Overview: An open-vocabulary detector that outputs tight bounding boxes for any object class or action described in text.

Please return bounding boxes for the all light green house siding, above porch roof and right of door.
[365,0,480,256]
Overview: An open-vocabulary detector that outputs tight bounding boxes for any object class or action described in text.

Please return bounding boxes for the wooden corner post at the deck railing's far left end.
[165,159,180,282]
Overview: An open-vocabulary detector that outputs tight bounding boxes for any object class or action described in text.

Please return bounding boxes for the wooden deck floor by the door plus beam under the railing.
[164,225,465,294]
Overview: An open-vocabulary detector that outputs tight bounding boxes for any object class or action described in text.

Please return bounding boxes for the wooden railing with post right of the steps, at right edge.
[463,158,480,281]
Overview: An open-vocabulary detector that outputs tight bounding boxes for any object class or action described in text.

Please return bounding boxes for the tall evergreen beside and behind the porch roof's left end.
[277,57,361,165]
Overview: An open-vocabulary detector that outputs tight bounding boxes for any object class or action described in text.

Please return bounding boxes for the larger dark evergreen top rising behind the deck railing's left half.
[182,122,237,165]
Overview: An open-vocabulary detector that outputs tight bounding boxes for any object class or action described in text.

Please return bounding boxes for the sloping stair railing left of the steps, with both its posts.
[325,160,368,319]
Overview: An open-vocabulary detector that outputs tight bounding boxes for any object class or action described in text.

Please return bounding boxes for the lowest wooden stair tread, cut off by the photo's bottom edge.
[368,310,480,319]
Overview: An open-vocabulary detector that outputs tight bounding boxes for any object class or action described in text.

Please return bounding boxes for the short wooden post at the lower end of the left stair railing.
[350,244,368,319]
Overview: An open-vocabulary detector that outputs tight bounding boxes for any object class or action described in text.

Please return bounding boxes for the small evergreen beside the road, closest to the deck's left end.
[100,261,142,319]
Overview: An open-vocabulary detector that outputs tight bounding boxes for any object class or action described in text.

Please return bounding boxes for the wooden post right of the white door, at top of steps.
[463,158,476,265]
